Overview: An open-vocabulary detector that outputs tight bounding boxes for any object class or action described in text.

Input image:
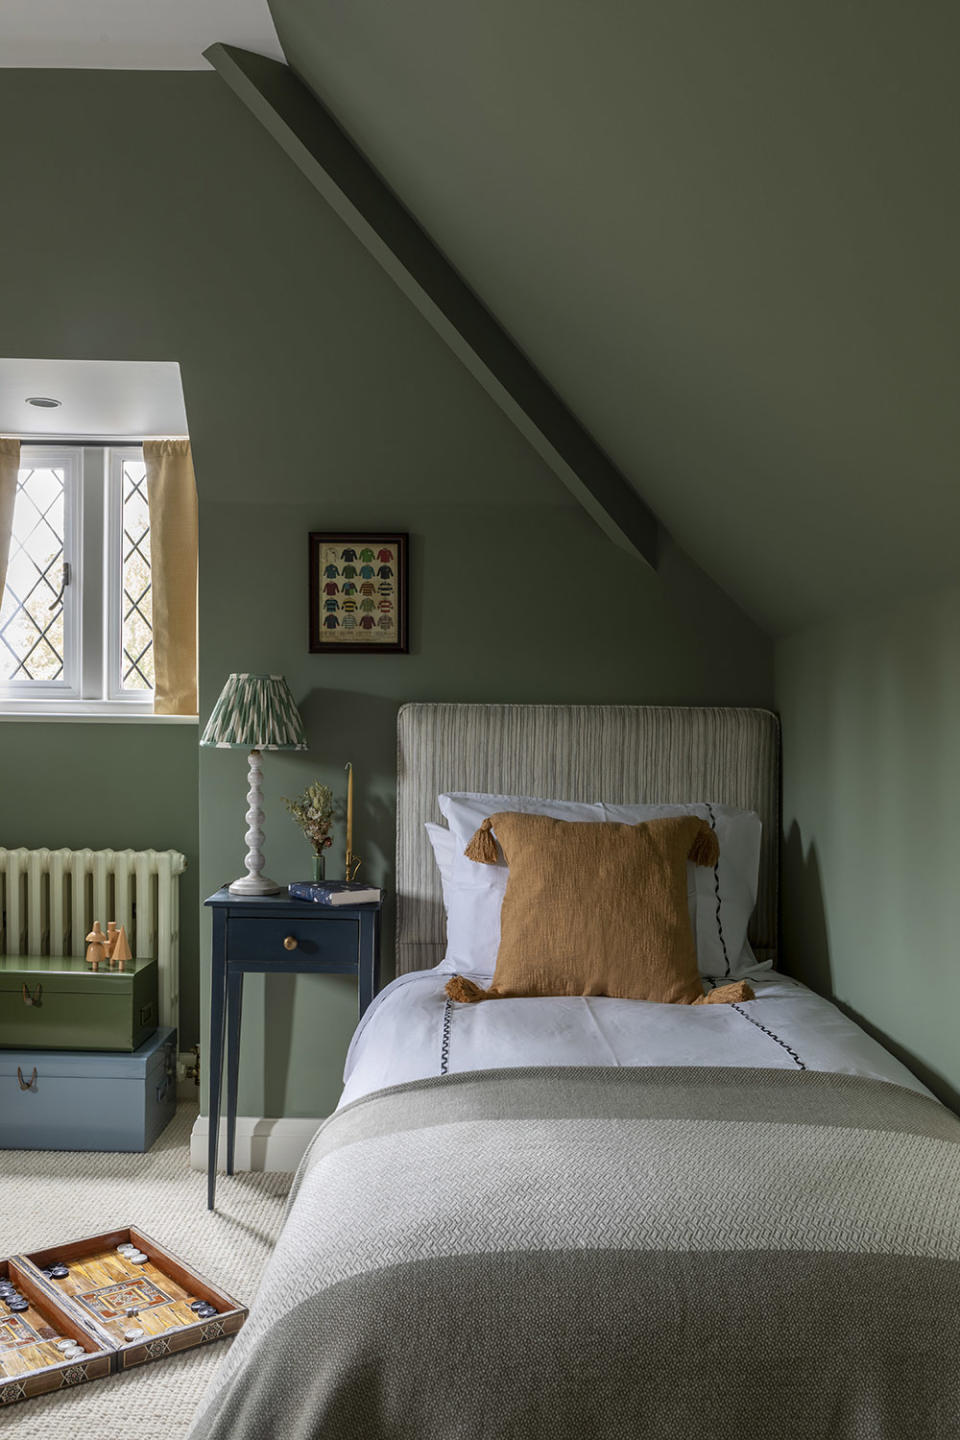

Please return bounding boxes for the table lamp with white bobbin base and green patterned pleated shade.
[200,675,307,896]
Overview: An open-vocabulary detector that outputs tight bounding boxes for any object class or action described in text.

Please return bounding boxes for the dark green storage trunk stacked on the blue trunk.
[0,955,158,1050]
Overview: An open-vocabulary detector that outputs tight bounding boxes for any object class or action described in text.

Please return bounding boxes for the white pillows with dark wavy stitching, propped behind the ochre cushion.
[426,793,770,979]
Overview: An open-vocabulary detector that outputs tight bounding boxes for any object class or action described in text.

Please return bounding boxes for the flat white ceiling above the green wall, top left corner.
[0,0,284,71]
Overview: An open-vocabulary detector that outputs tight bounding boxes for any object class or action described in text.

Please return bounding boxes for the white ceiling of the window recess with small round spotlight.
[0,360,187,439]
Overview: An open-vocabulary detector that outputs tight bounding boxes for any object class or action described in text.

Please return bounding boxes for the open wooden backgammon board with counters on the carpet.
[0,1227,246,1407]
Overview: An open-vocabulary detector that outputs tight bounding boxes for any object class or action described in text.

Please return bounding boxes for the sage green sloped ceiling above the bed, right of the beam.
[271,0,960,631]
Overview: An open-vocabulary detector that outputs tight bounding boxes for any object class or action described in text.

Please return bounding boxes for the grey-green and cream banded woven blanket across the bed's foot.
[190,1067,960,1440]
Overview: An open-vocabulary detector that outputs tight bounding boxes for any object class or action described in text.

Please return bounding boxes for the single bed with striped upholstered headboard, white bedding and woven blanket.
[191,706,960,1440]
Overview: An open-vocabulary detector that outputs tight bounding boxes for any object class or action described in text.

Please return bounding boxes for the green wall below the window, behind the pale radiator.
[0,720,200,1048]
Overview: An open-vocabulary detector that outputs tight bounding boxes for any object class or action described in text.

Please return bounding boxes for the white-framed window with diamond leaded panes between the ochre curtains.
[0,444,154,714]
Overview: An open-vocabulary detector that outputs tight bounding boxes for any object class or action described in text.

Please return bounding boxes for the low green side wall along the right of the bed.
[776,588,960,1107]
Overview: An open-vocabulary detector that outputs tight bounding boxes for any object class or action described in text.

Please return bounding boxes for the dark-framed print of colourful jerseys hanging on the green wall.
[309,530,407,655]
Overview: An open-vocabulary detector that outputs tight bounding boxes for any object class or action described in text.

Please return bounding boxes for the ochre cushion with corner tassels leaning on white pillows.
[449,811,728,1005]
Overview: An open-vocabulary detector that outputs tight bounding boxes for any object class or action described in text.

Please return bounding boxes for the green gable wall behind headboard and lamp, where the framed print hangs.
[0,71,773,1115]
